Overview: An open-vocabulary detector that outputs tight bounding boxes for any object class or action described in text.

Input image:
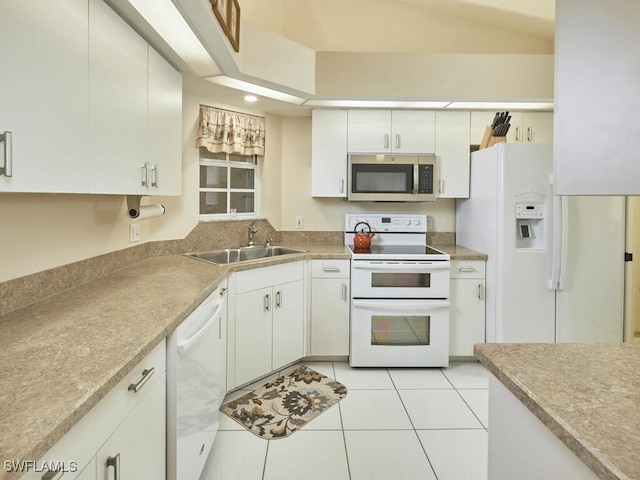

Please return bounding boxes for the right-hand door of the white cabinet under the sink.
[272,280,304,370]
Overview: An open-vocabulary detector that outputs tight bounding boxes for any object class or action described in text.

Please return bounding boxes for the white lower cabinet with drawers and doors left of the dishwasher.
[21,341,166,480]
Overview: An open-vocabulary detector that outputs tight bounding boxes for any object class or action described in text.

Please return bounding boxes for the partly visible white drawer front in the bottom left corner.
[19,408,96,480]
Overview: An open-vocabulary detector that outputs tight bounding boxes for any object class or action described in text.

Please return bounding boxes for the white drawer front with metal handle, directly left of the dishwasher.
[95,340,166,447]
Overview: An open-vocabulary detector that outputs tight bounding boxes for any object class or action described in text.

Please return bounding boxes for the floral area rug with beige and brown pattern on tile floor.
[220,365,347,440]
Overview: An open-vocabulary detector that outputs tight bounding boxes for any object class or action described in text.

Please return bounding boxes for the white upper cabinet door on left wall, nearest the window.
[146,47,182,195]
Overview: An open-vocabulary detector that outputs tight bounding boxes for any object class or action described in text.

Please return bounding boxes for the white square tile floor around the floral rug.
[200,362,489,480]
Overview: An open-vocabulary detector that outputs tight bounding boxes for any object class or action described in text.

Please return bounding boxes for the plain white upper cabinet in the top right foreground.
[554,0,640,195]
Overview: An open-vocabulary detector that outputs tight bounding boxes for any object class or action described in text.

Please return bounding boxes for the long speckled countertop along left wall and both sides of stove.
[0,244,486,480]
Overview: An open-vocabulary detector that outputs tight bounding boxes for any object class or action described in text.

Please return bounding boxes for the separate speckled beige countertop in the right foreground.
[474,344,640,480]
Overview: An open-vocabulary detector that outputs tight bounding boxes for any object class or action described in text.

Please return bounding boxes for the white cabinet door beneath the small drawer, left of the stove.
[311,278,349,355]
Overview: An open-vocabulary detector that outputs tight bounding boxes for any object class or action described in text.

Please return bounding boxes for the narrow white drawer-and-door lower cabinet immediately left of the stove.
[311,260,351,356]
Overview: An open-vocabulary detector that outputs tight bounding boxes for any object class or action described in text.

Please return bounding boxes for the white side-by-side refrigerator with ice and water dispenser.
[456,143,625,342]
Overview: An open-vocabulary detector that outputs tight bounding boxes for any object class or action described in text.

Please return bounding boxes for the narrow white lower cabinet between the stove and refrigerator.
[449,260,485,357]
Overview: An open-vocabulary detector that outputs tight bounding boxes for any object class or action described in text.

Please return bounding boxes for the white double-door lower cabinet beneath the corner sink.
[227,262,304,388]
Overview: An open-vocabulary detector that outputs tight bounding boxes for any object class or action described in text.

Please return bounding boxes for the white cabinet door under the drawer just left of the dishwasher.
[96,372,166,480]
